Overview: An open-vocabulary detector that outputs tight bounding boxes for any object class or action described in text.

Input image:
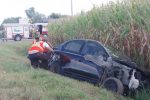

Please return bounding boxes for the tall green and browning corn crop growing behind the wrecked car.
[49,0,150,68]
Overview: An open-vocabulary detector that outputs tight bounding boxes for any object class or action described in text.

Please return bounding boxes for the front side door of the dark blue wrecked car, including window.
[78,41,109,79]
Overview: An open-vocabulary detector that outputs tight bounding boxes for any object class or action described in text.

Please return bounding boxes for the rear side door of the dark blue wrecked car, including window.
[61,40,85,76]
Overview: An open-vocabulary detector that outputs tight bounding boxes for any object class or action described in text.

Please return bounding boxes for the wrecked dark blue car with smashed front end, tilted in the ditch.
[49,39,148,95]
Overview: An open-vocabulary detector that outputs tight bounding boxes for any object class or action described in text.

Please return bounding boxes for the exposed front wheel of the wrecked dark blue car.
[102,77,124,94]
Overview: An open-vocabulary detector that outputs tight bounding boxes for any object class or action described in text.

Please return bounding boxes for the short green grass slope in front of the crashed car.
[0,41,128,100]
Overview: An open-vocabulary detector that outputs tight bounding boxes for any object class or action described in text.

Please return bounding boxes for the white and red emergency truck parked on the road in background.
[3,23,48,41]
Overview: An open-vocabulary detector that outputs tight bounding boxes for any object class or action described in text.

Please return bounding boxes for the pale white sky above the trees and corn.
[0,0,117,23]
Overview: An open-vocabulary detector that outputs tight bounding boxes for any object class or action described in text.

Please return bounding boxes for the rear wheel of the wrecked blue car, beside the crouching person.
[50,62,61,74]
